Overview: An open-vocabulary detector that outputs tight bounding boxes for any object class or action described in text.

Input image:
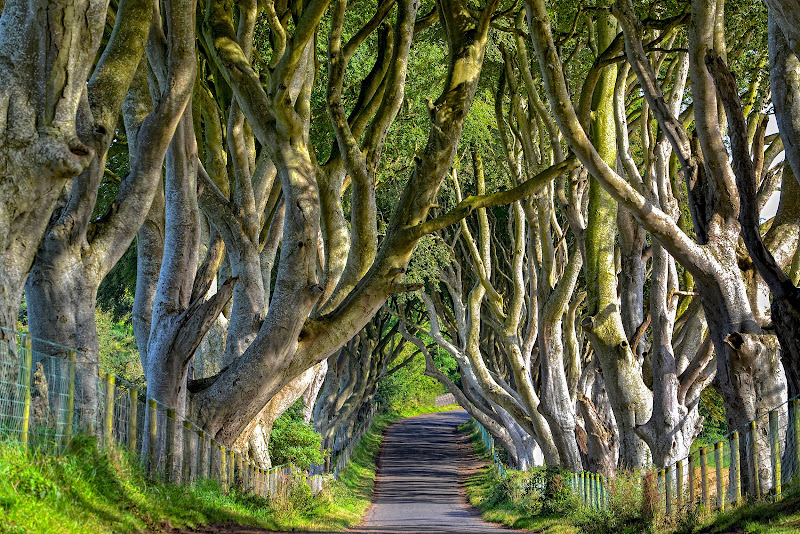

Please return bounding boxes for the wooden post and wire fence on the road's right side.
[475,396,800,516]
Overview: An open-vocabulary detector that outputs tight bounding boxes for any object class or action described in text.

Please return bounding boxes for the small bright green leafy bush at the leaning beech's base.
[269,399,327,469]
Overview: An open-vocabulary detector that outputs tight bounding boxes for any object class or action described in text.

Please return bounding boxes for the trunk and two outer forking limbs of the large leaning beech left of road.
[196,2,494,448]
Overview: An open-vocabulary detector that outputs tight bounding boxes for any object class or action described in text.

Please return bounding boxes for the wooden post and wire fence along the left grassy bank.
[0,329,325,498]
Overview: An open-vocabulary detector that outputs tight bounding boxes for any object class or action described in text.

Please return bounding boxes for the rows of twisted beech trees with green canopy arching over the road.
[0,0,800,494]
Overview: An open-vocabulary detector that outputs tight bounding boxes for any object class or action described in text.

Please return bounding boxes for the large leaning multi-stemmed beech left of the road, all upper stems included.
[164,2,512,450]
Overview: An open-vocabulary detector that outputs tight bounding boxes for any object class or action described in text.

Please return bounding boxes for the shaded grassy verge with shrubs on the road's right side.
[460,422,800,534]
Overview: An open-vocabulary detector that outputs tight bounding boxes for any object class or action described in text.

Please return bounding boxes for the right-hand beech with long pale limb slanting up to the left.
[526,0,785,482]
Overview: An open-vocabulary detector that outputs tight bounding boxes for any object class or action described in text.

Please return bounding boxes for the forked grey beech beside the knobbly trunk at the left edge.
[25,1,195,426]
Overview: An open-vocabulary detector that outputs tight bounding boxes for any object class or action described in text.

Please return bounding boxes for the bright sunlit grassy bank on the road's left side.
[0,415,399,534]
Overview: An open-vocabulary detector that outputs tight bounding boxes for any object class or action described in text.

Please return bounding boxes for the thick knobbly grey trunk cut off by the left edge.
[0,0,108,340]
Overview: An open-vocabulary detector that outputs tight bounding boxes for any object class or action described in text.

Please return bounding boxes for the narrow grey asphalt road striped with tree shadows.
[350,410,513,534]
